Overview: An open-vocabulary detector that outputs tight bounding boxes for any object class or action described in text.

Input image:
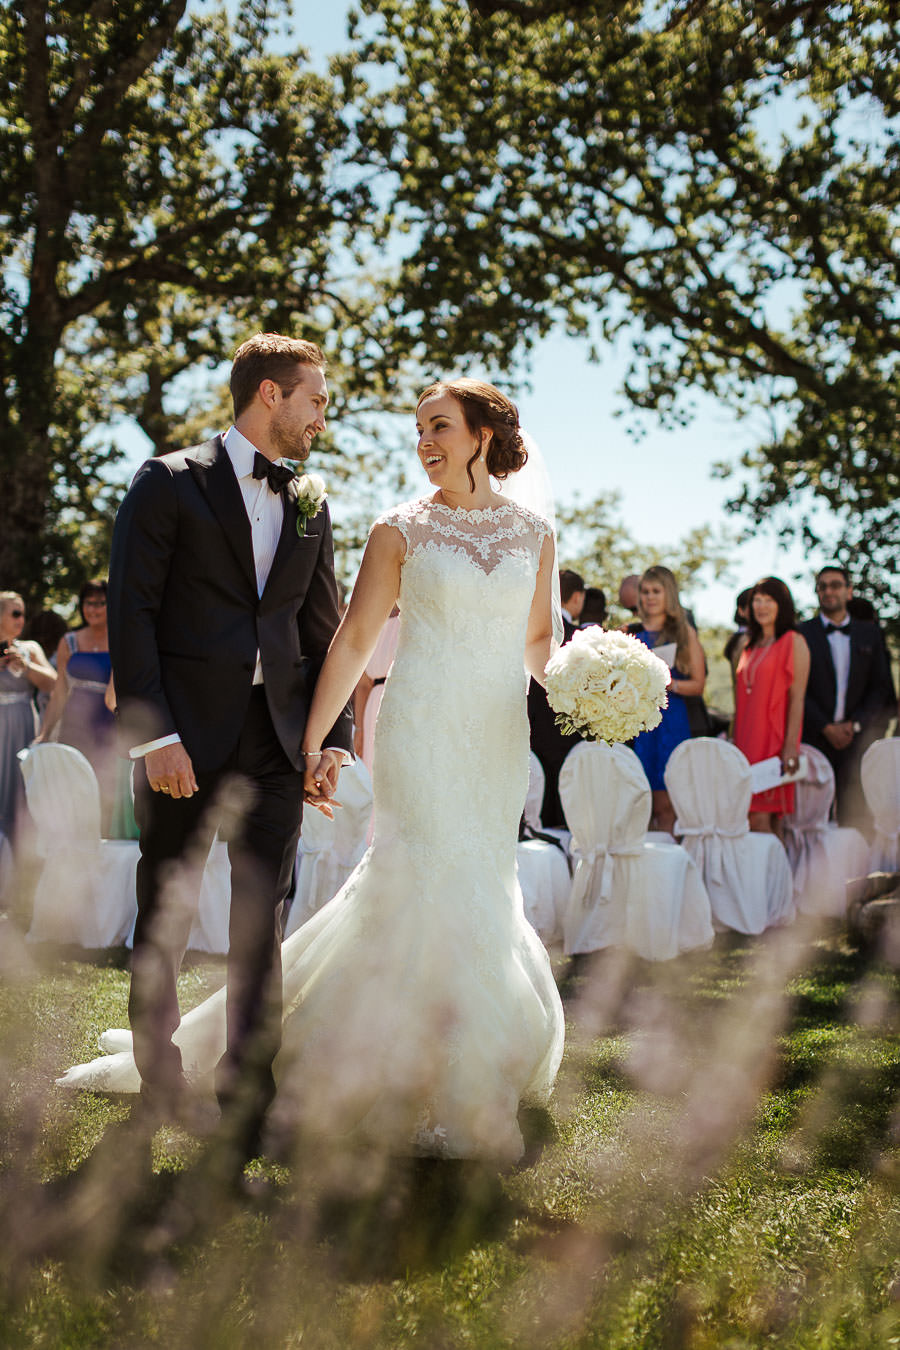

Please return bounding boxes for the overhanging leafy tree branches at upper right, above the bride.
[363,0,900,612]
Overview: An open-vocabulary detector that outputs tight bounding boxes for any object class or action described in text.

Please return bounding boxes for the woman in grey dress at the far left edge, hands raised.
[0,591,57,842]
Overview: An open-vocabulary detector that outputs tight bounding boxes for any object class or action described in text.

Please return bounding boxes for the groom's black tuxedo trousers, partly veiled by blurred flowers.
[128,686,302,1121]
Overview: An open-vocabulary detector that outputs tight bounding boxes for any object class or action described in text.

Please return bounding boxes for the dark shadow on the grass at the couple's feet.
[22,1108,556,1289]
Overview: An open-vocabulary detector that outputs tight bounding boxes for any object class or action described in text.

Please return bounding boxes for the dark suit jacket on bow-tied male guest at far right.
[799,616,895,755]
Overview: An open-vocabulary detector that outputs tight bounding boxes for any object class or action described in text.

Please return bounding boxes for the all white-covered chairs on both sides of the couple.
[14,738,900,960]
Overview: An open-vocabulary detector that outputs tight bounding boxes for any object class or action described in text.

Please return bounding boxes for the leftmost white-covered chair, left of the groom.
[19,744,139,948]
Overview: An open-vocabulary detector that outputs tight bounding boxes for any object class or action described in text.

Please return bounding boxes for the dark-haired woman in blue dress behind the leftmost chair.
[38,579,120,838]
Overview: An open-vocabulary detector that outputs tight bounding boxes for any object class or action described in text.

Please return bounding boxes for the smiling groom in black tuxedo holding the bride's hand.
[109,333,351,1154]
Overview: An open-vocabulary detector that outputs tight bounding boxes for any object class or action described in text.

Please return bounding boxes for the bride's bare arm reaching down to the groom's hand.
[301,525,406,787]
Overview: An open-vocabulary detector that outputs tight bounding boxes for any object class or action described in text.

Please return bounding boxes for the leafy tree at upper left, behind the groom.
[0,0,388,598]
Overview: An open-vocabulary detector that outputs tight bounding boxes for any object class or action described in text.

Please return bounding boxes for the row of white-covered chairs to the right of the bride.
[519,738,900,960]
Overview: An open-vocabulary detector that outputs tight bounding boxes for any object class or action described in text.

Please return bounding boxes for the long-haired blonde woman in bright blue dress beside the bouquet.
[631,567,706,834]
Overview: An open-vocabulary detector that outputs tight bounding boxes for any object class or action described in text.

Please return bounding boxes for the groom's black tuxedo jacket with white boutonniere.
[109,436,352,772]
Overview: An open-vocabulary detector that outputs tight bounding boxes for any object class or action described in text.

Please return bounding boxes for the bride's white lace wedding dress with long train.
[62,500,563,1160]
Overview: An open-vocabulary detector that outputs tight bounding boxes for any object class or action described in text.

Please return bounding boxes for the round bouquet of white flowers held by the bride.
[546,626,671,745]
